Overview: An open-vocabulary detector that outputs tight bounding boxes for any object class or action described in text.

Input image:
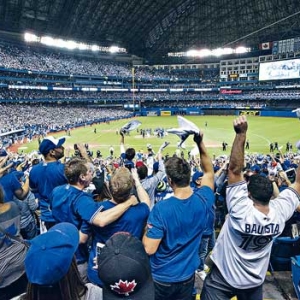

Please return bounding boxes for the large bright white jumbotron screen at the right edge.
[258,59,300,81]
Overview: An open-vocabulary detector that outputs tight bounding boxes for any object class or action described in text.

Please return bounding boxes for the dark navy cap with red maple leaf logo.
[98,232,155,300]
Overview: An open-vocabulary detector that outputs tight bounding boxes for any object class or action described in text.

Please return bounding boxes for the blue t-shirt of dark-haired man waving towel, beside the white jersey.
[146,186,215,282]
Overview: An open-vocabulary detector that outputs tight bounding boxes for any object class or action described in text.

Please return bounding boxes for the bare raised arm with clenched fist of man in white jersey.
[228,116,248,184]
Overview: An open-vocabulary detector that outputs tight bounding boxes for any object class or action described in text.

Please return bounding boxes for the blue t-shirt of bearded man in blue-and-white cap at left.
[29,161,67,222]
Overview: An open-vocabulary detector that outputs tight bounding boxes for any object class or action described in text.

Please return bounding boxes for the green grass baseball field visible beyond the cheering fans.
[21,116,300,157]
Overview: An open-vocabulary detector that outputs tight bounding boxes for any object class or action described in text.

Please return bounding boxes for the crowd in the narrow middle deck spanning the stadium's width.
[0,88,299,108]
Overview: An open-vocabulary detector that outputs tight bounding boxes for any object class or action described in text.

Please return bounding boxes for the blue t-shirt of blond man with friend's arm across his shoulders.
[81,201,150,286]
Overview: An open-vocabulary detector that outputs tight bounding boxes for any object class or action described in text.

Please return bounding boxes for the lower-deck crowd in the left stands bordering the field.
[0,104,132,146]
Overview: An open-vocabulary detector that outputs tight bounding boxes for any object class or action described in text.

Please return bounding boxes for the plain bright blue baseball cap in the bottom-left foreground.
[25,223,79,285]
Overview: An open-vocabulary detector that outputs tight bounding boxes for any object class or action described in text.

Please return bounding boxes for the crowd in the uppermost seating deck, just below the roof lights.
[0,45,205,81]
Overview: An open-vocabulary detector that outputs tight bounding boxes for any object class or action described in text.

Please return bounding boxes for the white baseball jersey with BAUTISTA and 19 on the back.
[211,181,300,289]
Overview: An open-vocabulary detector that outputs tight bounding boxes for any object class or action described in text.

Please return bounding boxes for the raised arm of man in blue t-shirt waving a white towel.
[194,133,214,190]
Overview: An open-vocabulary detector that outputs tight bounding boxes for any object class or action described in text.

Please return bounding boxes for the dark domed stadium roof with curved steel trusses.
[0,0,300,62]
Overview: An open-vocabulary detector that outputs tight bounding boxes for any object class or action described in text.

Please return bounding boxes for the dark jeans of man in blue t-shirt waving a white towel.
[154,274,195,300]
